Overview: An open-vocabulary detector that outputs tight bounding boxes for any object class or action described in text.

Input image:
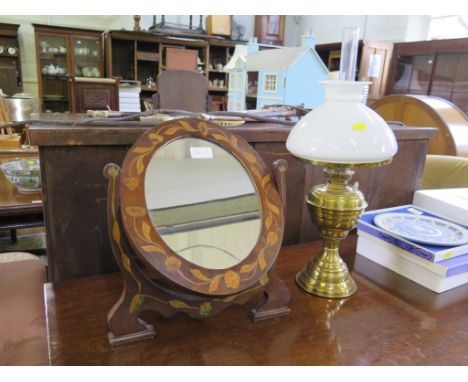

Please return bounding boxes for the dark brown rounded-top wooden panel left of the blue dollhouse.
[153,70,209,113]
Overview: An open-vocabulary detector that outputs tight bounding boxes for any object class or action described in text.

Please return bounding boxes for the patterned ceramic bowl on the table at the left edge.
[0,159,41,192]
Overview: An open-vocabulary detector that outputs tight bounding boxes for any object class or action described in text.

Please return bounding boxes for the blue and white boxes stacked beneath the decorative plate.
[357,205,468,293]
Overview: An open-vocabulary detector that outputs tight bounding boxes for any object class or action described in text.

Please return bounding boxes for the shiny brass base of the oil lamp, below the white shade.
[296,163,367,298]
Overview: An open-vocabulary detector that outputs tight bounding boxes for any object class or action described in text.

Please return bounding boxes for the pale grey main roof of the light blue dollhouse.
[247,47,326,72]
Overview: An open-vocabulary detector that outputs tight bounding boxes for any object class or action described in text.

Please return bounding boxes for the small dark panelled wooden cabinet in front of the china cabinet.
[70,77,119,113]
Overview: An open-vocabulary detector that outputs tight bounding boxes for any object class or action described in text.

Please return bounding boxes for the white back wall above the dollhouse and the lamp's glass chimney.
[285,15,430,46]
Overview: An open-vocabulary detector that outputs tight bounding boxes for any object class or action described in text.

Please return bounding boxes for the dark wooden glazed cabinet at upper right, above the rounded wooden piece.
[387,38,468,113]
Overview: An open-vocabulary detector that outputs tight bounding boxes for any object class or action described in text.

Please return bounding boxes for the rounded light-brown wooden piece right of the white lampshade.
[371,94,468,157]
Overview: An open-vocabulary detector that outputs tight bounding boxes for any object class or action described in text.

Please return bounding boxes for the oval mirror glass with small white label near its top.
[145,137,261,269]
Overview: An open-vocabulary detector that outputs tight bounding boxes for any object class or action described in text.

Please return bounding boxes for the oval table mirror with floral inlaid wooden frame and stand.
[104,119,289,345]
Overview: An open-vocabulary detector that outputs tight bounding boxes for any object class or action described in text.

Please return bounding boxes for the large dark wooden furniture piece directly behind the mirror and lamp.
[30,121,436,280]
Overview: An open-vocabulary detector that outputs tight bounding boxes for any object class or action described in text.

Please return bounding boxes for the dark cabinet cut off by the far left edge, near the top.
[0,23,23,95]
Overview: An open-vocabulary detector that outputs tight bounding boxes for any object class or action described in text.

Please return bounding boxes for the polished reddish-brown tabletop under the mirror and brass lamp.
[45,236,468,365]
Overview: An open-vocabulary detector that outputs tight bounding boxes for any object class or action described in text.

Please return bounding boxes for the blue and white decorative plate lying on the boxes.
[374,212,468,246]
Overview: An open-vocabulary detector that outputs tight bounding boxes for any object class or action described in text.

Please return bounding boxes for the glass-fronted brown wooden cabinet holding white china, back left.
[33,24,104,112]
